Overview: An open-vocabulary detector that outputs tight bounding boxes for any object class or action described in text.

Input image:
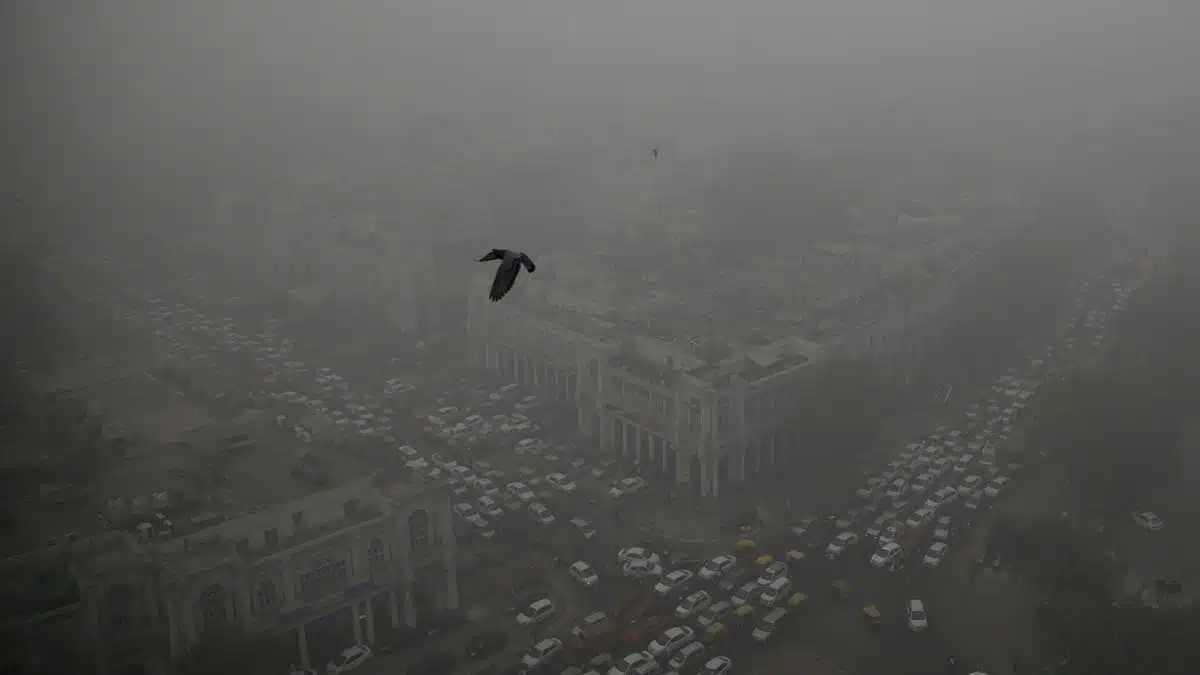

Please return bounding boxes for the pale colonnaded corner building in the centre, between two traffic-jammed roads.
[468,247,969,496]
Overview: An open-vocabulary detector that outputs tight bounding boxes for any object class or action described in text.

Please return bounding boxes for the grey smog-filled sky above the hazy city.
[0,0,1200,205]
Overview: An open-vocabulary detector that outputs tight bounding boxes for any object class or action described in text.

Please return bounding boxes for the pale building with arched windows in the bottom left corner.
[4,478,458,675]
